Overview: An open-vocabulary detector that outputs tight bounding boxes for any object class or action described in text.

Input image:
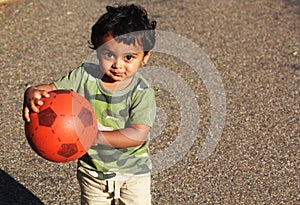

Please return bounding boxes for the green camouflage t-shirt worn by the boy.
[54,63,156,179]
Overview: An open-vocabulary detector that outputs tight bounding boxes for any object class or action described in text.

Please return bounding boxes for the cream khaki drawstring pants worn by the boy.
[77,166,151,205]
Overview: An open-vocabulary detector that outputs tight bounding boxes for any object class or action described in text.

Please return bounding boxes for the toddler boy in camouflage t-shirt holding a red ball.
[23,4,156,205]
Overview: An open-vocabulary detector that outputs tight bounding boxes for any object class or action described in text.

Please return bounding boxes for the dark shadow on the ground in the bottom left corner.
[0,169,43,205]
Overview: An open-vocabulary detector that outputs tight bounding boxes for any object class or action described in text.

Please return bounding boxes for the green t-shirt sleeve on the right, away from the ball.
[130,87,156,127]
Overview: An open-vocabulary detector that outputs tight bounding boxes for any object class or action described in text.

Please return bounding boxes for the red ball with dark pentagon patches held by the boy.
[25,90,98,162]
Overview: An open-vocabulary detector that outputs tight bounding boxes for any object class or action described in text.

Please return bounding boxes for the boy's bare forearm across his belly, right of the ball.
[94,124,150,148]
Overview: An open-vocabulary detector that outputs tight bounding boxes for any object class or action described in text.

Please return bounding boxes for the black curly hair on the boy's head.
[90,4,156,53]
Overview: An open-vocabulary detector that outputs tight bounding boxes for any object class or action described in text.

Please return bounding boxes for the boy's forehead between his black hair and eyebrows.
[97,35,144,53]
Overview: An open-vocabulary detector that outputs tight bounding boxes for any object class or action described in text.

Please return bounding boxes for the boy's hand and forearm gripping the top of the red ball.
[23,83,57,122]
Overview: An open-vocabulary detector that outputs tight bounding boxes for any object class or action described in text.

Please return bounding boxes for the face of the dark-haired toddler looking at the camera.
[97,35,151,82]
